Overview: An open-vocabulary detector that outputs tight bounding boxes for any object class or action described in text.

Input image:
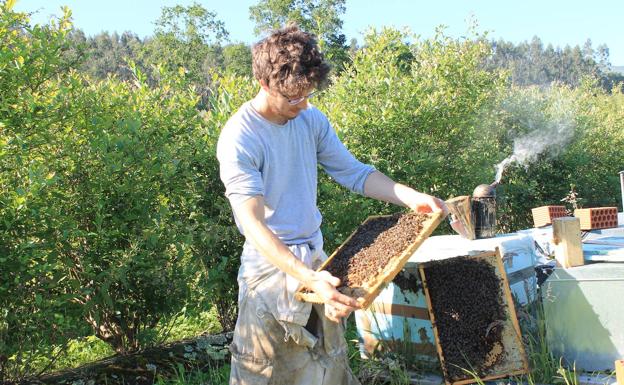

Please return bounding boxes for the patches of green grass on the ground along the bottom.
[14,292,616,385]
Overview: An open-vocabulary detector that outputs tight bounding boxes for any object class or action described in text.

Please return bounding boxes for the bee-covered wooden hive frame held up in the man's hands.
[295,212,445,308]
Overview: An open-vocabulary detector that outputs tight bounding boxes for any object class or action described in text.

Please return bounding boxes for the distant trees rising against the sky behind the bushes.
[50,0,624,92]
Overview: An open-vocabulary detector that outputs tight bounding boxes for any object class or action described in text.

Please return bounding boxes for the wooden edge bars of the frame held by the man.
[295,212,445,308]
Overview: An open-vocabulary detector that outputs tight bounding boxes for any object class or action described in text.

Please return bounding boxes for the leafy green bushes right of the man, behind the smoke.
[319,29,624,238]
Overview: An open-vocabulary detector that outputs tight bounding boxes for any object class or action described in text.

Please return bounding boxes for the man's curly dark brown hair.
[252,24,330,96]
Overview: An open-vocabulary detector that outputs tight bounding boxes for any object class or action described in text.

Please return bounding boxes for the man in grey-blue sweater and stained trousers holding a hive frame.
[217,25,454,384]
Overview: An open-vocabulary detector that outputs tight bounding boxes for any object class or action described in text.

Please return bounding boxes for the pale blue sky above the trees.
[16,0,624,66]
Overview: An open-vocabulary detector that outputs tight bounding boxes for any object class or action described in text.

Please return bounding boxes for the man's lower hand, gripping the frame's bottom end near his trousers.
[306,270,360,322]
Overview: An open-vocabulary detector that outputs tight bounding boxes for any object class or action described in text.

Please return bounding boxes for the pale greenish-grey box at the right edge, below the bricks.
[542,263,624,371]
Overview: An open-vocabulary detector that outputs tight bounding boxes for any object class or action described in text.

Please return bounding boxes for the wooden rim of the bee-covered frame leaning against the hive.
[419,248,529,385]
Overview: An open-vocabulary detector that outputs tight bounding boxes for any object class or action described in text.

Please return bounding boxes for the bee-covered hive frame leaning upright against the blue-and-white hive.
[420,249,528,385]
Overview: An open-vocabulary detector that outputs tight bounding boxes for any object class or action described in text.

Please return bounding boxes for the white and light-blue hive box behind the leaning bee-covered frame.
[354,234,540,371]
